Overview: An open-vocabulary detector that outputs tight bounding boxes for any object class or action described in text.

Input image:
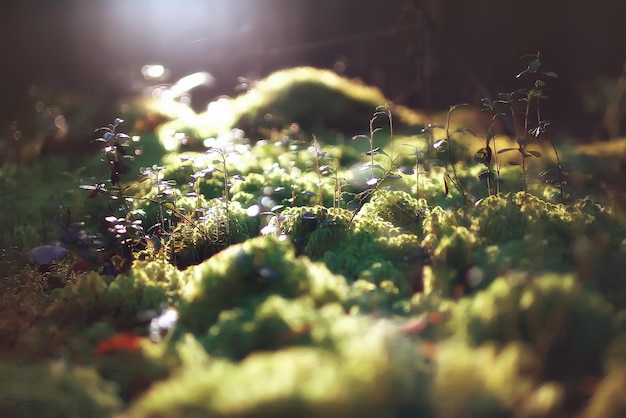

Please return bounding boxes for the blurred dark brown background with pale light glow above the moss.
[0,0,626,152]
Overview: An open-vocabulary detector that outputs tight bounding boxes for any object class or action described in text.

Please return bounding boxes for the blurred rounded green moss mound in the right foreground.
[454,274,613,379]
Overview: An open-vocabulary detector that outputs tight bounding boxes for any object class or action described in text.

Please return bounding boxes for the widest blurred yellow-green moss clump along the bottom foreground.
[128,315,432,417]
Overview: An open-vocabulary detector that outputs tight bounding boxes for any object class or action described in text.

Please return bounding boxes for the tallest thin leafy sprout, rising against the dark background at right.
[498,52,560,196]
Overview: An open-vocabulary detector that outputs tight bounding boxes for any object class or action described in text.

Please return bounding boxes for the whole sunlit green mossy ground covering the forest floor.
[0,69,626,418]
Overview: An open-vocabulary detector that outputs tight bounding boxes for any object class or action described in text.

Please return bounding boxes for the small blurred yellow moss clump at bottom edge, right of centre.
[433,341,563,418]
